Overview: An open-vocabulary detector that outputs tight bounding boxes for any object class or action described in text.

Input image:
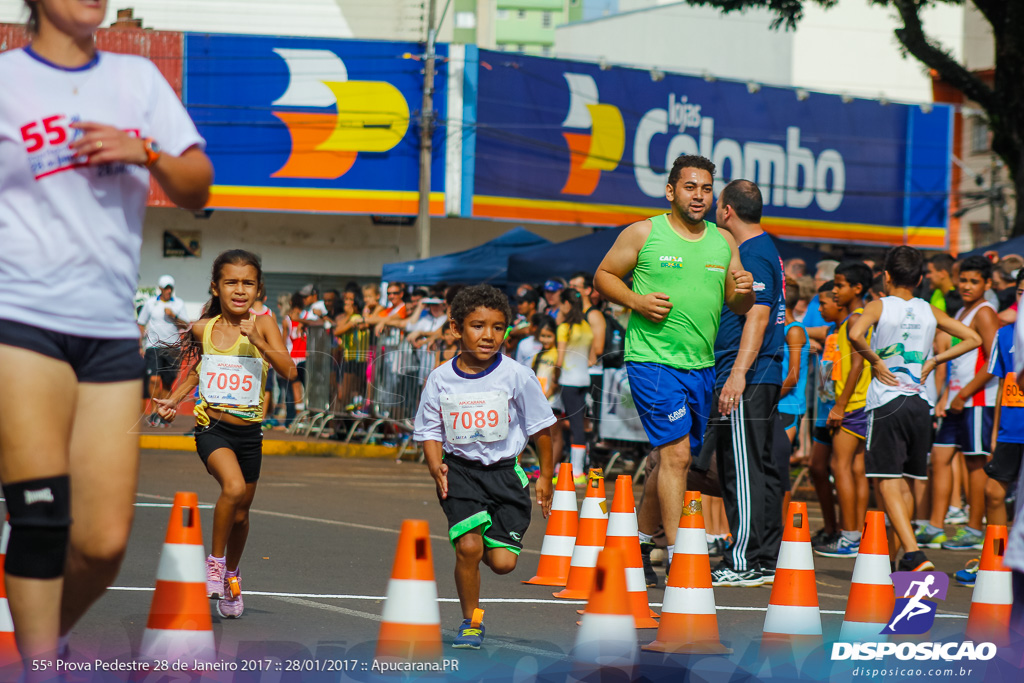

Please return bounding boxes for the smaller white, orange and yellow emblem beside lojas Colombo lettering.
[562,74,626,196]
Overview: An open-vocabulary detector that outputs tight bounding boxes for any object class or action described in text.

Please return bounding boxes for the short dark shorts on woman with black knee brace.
[0,321,143,384]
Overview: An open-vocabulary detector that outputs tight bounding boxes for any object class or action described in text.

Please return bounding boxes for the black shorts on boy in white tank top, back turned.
[864,395,932,479]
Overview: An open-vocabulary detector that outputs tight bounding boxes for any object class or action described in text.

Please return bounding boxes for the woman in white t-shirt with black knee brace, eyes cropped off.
[0,0,213,681]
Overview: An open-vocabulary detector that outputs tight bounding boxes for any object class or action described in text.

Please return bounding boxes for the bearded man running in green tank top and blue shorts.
[594,155,754,584]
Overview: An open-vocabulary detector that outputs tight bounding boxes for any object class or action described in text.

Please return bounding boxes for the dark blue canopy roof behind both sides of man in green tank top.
[508,225,827,287]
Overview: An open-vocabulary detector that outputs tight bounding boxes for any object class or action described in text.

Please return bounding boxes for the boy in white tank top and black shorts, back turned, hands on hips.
[850,247,981,571]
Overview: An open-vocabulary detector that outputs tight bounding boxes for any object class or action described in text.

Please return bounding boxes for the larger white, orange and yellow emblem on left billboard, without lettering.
[271,48,409,178]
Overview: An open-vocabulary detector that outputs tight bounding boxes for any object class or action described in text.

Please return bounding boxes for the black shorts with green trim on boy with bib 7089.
[437,453,534,555]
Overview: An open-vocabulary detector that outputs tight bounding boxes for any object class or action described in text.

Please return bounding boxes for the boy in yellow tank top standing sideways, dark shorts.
[814,261,871,557]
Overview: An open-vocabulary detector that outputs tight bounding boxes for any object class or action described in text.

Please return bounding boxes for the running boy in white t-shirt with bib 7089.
[413,285,555,649]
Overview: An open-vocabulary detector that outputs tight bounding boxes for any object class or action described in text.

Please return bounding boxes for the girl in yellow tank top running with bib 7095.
[157,249,298,618]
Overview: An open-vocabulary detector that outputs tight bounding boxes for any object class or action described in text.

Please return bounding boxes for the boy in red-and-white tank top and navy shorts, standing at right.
[920,256,999,550]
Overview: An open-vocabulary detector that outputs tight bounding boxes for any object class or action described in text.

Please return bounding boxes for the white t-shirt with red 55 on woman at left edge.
[0,48,204,339]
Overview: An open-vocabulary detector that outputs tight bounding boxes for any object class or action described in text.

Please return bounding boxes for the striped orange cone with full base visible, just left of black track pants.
[643,490,732,654]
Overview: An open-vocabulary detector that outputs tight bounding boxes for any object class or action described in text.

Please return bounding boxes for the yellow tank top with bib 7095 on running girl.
[195,315,267,427]
